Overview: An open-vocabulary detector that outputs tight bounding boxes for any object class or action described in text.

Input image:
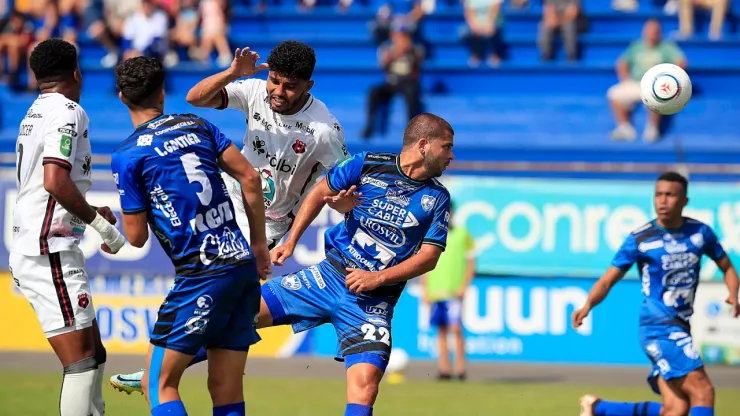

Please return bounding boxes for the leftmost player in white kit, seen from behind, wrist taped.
[10,39,125,416]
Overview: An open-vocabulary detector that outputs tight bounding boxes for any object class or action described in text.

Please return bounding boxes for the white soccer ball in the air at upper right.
[640,64,692,116]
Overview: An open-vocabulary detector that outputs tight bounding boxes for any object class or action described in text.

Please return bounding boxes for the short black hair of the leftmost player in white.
[28,38,77,82]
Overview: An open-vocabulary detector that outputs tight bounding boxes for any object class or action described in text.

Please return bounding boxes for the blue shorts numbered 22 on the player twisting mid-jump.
[262,260,396,371]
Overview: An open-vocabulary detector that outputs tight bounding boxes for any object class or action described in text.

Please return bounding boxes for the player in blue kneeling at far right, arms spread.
[573,172,740,416]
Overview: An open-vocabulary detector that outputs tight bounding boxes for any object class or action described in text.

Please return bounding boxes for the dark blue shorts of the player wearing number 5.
[150,262,260,355]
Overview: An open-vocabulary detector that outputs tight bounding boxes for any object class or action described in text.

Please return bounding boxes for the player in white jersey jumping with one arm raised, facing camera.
[187,41,349,249]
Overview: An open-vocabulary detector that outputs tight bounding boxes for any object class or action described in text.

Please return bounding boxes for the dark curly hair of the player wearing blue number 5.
[116,56,164,108]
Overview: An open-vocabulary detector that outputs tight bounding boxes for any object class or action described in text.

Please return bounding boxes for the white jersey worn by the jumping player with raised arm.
[219,79,349,224]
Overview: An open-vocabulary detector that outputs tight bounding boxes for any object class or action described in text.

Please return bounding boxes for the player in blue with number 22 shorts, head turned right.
[259,113,454,416]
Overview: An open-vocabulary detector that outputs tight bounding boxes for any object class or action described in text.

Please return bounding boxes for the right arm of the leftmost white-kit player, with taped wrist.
[43,107,125,253]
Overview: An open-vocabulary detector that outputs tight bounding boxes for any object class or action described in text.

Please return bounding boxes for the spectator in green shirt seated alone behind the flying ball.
[606,19,687,142]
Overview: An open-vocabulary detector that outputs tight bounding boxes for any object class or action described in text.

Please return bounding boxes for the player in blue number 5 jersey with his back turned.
[111,57,270,416]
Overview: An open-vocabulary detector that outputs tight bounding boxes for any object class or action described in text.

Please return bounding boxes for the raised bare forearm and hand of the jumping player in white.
[185,48,267,108]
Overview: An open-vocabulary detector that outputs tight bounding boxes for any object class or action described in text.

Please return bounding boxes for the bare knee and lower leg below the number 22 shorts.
[344,353,388,416]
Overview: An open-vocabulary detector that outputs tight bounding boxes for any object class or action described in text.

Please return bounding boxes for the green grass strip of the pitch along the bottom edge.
[0,372,740,416]
